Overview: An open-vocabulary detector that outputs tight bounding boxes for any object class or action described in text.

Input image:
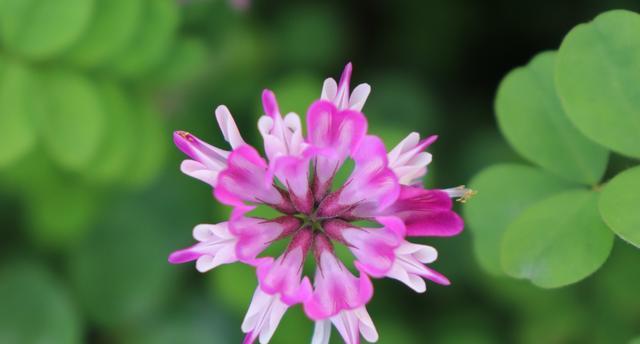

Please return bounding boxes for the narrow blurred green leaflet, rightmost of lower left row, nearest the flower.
[127,99,171,186]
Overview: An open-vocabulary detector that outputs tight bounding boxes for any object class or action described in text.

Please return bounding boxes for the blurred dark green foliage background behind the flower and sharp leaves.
[0,0,640,344]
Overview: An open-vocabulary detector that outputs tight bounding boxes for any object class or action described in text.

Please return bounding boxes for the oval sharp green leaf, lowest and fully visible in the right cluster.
[501,190,613,288]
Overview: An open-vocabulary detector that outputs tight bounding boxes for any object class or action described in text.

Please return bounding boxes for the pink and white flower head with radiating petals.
[169,63,473,344]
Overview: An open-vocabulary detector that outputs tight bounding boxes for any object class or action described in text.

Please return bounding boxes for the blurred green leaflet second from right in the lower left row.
[85,81,136,183]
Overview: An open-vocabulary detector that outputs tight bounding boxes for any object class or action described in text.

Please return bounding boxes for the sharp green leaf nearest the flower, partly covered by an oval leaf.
[463,164,575,274]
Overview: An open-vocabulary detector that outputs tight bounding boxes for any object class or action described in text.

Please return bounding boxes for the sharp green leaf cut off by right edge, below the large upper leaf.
[598,166,640,248]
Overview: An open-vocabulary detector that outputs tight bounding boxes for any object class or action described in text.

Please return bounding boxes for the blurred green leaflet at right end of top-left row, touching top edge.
[111,0,179,78]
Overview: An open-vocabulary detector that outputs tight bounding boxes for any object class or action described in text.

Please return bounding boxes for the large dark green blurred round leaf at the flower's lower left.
[68,199,177,330]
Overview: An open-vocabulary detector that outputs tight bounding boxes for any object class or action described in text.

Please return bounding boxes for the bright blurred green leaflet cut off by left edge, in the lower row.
[0,60,38,168]
